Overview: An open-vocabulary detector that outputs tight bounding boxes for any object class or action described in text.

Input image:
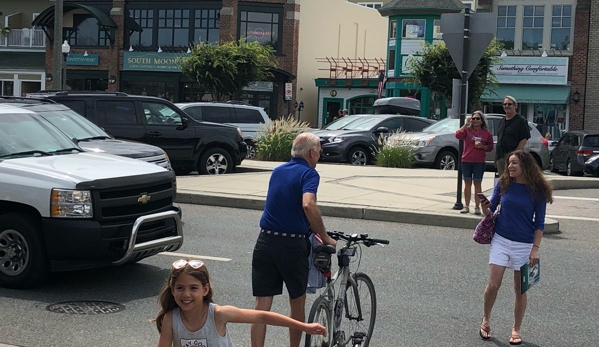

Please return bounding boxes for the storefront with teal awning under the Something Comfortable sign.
[481,57,570,139]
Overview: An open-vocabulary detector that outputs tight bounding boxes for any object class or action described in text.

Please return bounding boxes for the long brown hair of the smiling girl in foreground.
[151,264,214,333]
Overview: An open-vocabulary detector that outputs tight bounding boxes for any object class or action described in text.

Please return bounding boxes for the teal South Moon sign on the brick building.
[123,52,187,72]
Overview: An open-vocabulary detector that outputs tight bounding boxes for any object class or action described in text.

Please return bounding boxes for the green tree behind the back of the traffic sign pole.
[408,40,502,109]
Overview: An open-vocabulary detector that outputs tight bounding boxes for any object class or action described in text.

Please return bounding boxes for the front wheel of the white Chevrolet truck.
[0,213,50,289]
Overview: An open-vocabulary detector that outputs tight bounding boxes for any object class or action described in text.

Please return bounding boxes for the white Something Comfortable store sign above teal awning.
[491,57,568,85]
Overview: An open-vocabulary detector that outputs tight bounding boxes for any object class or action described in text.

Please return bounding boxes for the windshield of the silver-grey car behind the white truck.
[38,110,110,141]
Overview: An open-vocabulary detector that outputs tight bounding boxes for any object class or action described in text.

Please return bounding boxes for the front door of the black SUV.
[139,100,199,166]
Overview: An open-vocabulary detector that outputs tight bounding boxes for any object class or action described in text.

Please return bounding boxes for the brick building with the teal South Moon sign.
[27,0,299,118]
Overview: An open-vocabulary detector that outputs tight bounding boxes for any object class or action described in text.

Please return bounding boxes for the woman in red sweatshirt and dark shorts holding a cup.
[455,111,493,215]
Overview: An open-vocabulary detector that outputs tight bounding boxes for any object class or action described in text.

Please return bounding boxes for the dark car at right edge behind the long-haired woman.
[549,130,599,176]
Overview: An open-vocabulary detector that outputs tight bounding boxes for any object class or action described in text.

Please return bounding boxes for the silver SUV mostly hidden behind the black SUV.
[175,102,270,159]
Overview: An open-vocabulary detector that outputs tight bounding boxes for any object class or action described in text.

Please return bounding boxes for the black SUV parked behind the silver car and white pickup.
[30,91,247,175]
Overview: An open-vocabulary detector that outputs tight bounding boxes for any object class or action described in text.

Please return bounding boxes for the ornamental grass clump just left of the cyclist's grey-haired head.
[255,115,310,161]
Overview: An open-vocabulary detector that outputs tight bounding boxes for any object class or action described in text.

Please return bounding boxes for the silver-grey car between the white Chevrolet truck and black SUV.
[0,97,172,170]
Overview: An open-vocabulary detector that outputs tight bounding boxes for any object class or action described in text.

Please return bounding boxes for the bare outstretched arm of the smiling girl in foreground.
[216,306,327,338]
